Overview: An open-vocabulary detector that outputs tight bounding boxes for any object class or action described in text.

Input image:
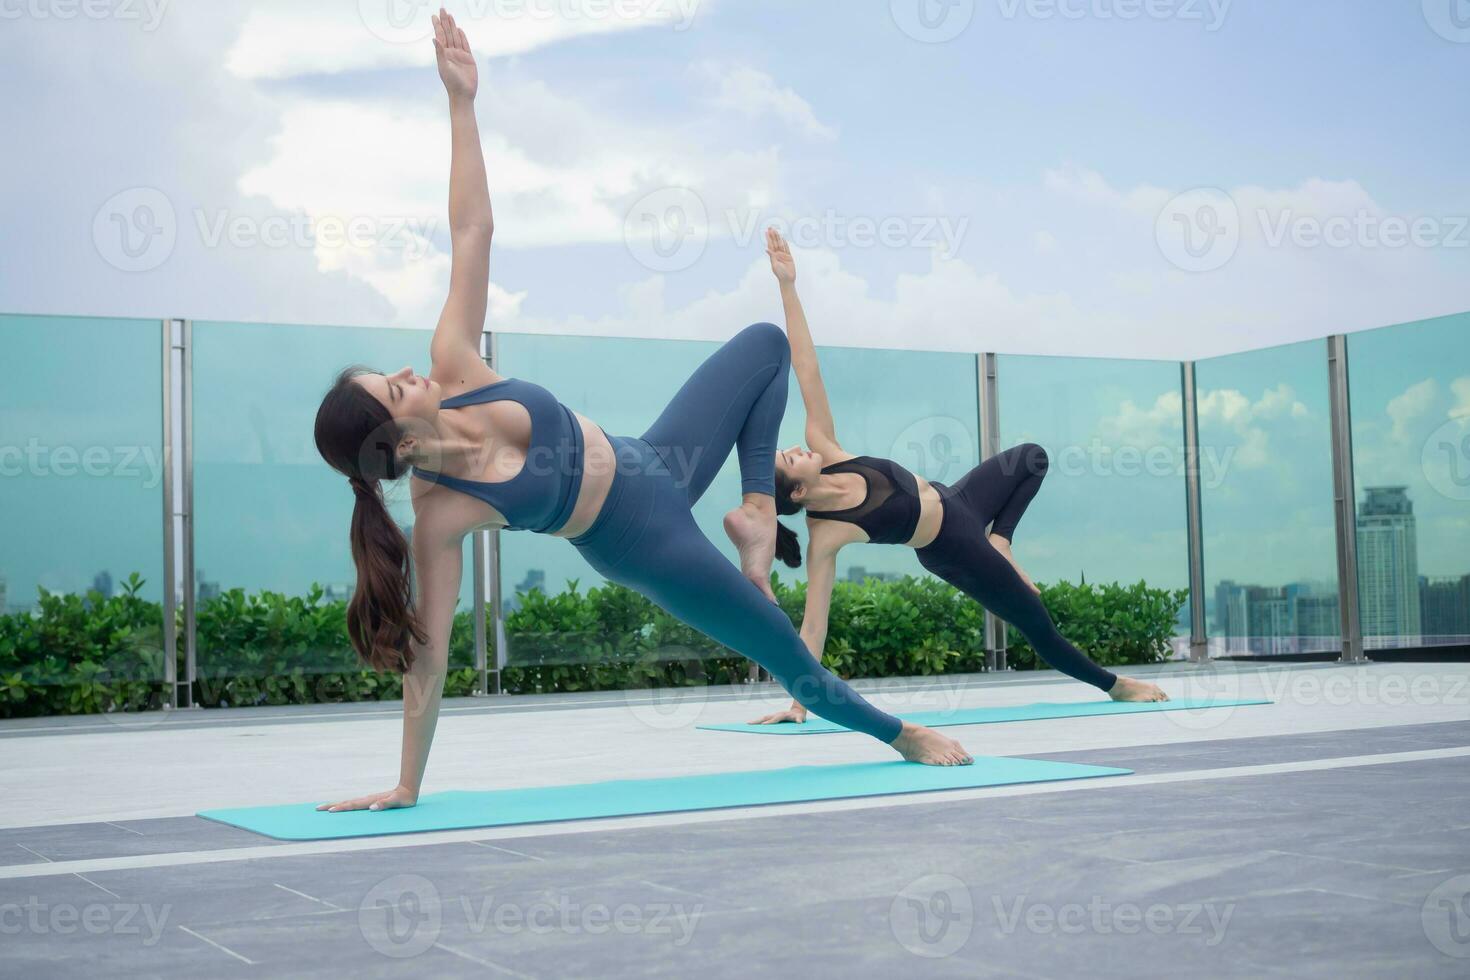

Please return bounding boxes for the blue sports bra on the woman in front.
[413,378,582,533]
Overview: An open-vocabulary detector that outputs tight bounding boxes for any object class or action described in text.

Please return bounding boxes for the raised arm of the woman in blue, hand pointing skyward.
[429,7,495,379]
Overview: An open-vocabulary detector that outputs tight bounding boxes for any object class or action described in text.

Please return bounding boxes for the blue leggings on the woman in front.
[572,323,903,742]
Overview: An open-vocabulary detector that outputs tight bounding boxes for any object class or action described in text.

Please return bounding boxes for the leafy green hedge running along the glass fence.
[0,573,1188,717]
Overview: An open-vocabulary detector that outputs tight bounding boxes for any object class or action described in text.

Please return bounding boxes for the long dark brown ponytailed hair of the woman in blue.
[316,364,429,673]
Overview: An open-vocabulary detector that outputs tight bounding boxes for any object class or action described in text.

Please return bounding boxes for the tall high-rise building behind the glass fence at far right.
[1357,486,1423,649]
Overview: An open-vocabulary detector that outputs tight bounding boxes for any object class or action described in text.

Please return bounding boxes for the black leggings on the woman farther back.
[917,442,1117,691]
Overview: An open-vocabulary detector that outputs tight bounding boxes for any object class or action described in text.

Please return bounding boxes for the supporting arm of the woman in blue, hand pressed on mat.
[318,517,465,813]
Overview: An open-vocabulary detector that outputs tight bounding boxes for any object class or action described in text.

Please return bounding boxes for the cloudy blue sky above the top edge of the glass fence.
[0,0,1470,360]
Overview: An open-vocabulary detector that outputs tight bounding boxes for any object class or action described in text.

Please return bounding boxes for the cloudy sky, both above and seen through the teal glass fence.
[0,0,1470,652]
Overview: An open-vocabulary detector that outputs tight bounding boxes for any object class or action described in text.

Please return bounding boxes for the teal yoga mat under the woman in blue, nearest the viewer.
[198,757,1132,840]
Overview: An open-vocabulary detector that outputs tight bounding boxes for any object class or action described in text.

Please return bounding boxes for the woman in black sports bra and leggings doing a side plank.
[757,229,1169,724]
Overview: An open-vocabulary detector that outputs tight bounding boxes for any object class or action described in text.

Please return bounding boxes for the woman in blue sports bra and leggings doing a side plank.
[316,9,973,811]
